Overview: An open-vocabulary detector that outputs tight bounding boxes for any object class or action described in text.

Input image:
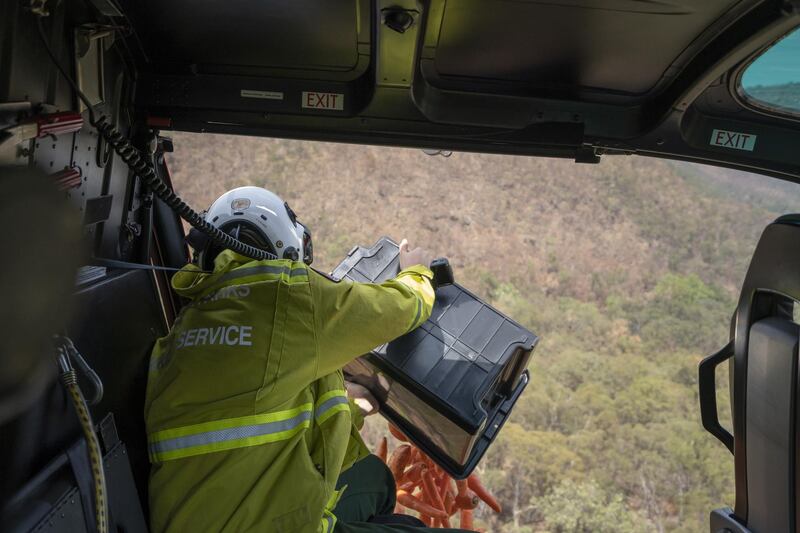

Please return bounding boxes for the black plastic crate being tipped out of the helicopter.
[332,237,538,479]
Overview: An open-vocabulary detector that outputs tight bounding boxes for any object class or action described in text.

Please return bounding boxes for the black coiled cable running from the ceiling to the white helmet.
[36,15,278,261]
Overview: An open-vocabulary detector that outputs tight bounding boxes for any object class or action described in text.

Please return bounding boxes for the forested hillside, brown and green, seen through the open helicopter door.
[170,134,800,533]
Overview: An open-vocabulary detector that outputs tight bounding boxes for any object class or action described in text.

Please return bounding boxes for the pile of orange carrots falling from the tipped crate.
[375,425,502,529]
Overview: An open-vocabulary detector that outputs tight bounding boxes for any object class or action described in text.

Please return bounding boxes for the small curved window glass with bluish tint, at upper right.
[741,29,800,115]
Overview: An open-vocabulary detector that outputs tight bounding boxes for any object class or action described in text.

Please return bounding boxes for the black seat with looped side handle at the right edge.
[699,215,800,533]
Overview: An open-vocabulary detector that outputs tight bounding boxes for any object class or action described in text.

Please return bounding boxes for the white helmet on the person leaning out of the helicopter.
[189,187,314,269]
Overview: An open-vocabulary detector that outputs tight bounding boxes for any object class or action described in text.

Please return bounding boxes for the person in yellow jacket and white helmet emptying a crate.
[145,187,476,533]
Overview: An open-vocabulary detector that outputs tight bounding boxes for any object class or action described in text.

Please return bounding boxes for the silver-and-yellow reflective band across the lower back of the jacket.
[148,403,313,463]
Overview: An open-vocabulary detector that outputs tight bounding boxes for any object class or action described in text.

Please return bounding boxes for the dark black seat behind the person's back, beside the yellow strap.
[0,270,167,533]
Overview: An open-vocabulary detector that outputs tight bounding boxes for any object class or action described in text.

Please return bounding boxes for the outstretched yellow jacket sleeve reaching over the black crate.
[309,258,434,377]
